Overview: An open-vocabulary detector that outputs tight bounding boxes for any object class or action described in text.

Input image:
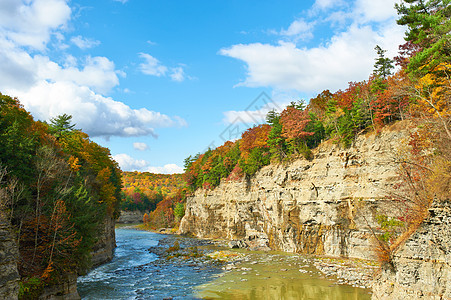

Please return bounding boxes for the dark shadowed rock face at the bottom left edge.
[0,212,19,299]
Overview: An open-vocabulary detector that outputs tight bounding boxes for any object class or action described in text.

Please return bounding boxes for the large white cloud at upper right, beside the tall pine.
[219,0,403,93]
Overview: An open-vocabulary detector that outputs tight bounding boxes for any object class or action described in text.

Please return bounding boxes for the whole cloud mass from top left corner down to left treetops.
[0,0,186,138]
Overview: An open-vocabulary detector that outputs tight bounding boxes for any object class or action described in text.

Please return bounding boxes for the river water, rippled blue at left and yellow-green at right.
[78,228,371,300]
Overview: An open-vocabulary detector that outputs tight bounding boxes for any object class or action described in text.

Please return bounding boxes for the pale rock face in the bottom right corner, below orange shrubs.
[373,201,451,300]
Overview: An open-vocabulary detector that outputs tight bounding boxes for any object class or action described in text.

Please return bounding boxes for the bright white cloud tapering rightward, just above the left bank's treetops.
[7,81,184,137]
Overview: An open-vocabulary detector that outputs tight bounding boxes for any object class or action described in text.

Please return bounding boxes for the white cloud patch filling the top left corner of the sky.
[0,0,71,50]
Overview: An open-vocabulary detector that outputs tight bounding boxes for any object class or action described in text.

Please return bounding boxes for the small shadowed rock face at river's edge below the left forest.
[91,215,116,267]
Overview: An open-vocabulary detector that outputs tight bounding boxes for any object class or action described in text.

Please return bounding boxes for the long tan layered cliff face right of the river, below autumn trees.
[180,125,406,259]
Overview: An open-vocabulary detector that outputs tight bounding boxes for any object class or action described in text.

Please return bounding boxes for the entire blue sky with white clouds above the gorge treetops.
[0,0,405,173]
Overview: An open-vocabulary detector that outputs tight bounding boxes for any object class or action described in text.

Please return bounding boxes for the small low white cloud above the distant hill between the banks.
[113,153,183,174]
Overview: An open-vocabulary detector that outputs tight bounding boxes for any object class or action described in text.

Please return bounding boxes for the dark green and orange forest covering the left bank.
[0,94,122,299]
